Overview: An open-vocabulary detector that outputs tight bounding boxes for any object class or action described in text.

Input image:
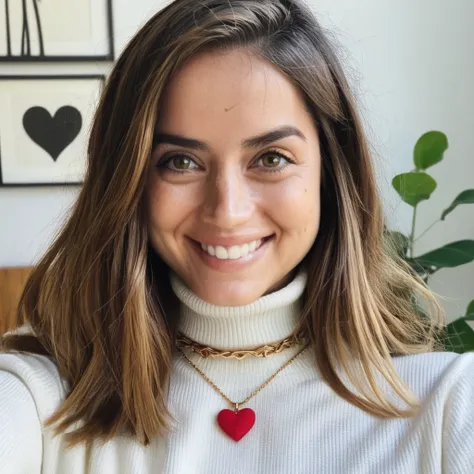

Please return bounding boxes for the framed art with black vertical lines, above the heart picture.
[0,0,114,62]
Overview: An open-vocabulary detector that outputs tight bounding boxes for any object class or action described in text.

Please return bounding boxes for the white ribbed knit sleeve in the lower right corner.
[443,353,474,474]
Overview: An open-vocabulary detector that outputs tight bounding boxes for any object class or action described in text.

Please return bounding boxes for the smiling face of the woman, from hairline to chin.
[147,50,321,306]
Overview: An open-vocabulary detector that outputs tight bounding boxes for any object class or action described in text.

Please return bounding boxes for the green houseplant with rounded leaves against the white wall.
[386,131,474,353]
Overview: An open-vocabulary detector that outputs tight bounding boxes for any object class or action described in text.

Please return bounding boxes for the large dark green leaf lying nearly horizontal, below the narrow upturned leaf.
[413,240,474,268]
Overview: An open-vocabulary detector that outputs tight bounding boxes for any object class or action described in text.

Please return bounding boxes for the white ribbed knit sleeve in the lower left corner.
[0,370,42,474]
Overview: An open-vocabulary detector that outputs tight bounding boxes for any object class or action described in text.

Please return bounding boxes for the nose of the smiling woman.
[201,167,254,229]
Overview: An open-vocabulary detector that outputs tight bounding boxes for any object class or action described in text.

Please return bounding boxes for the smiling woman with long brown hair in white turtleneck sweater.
[0,0,474,474]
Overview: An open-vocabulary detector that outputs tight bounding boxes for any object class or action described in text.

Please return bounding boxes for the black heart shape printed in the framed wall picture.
[23,105,82,161]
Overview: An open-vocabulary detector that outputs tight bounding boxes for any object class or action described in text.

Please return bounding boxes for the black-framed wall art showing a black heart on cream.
[0,76,104,186]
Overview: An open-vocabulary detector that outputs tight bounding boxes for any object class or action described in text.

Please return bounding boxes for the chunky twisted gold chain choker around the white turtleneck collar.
[176,329,309,360]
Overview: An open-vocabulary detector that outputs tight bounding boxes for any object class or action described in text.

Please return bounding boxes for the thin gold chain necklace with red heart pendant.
[178,343,309,441]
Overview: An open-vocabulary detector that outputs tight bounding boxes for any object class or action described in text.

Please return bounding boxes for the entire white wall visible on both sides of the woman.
[0,0,474,318]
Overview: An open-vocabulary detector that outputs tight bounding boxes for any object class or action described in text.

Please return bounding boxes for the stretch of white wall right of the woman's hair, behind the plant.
[311,0,474,319]
